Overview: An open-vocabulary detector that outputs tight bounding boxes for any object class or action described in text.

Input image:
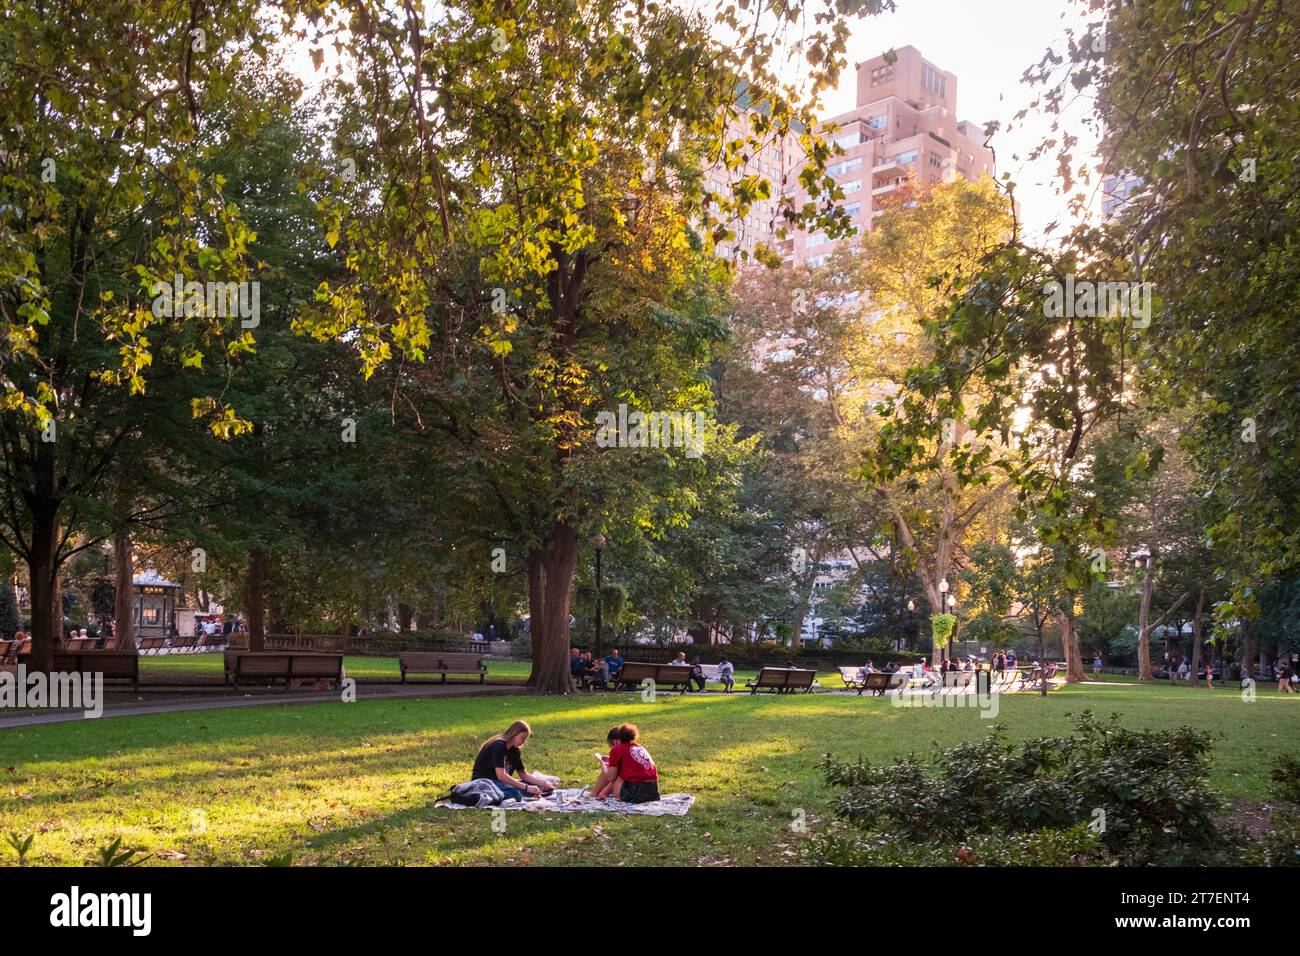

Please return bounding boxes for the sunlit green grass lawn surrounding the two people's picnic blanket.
[0,681,1300,865]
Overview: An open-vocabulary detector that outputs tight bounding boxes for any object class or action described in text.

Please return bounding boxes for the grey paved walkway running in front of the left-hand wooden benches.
[0,682,524,730]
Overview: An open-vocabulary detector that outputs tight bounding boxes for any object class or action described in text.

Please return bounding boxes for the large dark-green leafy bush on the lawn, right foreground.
[818,711,1242,866]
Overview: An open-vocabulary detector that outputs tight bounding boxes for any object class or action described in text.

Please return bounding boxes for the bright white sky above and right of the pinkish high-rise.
[826,0,1100,241]
